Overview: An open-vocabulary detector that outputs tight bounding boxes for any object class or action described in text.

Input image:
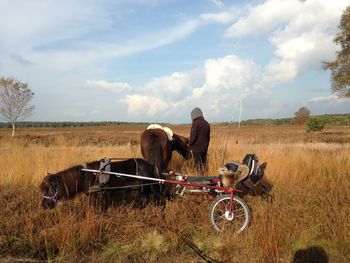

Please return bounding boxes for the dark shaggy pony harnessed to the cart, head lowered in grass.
[40,158,160,210]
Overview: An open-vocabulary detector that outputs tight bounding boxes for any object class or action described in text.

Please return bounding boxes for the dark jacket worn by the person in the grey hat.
[189,117,210,153]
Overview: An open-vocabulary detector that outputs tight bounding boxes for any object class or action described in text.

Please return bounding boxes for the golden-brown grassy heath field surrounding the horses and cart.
[0,125,350,262]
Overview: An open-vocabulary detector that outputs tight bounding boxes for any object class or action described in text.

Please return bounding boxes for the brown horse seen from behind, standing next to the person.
[140,129,191,172]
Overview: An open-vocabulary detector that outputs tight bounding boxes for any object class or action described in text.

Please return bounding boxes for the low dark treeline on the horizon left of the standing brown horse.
[0,121,149,128]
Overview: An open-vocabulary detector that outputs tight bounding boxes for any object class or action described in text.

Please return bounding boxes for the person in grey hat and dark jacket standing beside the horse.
[188,108,210,172]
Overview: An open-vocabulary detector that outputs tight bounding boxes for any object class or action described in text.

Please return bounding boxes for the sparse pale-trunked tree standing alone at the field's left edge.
[0,78,34,137]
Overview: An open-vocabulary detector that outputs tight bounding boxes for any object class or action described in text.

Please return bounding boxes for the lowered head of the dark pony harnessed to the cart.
[40,174,61,209]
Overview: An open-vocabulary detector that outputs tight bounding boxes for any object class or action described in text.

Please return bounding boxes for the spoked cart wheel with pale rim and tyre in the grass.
[209,195,250,233]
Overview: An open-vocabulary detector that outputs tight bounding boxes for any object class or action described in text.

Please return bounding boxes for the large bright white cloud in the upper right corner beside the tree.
[220,0,350,86]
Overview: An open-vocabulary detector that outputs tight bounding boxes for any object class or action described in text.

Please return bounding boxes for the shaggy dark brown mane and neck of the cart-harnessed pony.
[39,161,100,199]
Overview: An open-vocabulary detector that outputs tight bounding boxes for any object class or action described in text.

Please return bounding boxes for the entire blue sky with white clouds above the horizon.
[0,0,350,123]
